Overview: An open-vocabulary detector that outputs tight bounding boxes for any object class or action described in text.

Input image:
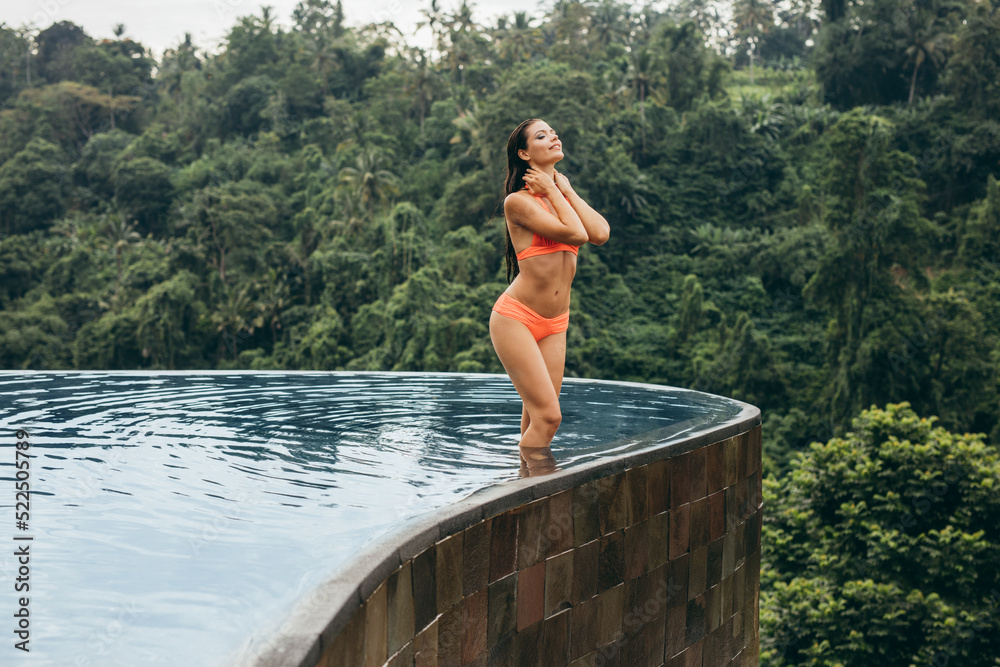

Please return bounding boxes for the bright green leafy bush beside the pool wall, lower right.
[760,403,1000,667]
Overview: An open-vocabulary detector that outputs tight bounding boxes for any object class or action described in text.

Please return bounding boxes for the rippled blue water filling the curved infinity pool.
[0,373,740,666]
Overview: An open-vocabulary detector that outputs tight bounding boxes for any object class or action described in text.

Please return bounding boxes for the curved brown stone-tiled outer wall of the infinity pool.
[258,421,762,667]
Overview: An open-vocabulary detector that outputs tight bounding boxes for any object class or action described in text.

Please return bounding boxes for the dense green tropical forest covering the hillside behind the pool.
[0,0,1000,665]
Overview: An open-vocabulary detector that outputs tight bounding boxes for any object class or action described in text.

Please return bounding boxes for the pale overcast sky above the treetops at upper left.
[0,0,551,58]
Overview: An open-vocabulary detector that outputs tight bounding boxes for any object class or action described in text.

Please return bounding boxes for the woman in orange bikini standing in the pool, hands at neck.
[490,118,611,474]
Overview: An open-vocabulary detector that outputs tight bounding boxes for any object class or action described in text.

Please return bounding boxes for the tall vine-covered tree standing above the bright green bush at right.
[805,109,930,420]
